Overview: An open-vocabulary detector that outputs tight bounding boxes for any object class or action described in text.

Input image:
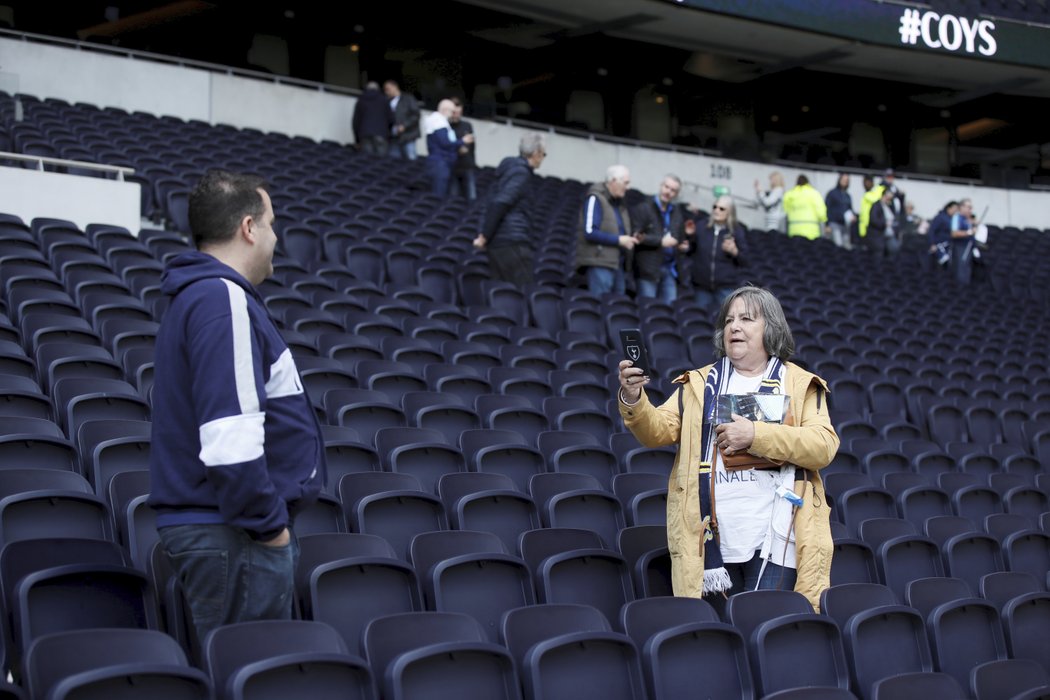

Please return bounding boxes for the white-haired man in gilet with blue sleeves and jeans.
[576,165,635,295]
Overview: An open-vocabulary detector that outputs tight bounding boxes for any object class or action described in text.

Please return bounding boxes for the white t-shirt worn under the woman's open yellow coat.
[715,372,778,564]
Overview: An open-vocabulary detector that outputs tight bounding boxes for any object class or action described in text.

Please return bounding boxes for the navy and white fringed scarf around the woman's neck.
[699,357,784,595]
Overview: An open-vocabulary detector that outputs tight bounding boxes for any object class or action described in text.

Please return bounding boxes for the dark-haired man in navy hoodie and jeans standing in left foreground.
[149,170,326,641]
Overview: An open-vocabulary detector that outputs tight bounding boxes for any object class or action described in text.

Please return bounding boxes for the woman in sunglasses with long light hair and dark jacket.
[688,194,748,311]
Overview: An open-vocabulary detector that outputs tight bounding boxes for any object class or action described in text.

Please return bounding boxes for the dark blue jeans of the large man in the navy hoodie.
[159,525,299,642]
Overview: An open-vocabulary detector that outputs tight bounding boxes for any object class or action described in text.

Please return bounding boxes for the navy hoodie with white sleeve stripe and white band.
[149,252,326,540]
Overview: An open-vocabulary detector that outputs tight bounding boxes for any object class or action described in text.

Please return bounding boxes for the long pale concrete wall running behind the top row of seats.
[0,38,1050,229]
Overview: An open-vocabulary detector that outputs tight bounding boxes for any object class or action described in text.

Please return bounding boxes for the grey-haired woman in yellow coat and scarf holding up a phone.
[618,287,839,611]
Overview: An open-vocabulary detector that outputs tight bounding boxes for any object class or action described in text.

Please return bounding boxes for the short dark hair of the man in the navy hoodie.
[189,170,267,249]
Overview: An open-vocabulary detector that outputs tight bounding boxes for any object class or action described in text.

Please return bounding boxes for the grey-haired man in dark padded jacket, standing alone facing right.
[474,133,547,287]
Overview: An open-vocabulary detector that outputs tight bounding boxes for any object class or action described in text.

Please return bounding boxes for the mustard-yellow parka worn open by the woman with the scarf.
[620,362,839,612]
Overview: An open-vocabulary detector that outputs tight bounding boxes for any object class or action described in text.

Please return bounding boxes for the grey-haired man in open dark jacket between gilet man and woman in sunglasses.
[631,174,696,303]
